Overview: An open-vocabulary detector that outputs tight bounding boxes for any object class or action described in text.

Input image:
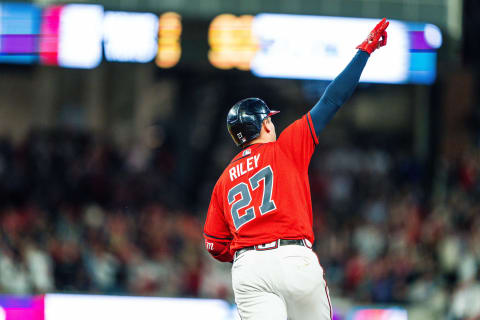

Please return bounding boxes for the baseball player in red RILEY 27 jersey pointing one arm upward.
[204,18,389,320]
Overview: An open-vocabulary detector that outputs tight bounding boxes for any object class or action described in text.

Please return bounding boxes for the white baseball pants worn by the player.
[232,245,332,320]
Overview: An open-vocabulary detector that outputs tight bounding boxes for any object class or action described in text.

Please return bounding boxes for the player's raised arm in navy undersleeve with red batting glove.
[310,18,389,136]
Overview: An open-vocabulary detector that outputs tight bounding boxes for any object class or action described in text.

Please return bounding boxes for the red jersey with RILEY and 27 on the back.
[204,113,318,261]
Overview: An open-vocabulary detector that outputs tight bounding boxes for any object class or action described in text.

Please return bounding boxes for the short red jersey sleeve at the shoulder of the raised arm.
[277,112,318,169]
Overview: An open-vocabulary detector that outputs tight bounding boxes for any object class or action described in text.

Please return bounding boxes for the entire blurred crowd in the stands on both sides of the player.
[0,131,480,319]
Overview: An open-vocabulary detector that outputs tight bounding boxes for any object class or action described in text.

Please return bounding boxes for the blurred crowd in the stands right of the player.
[311,147,480,319]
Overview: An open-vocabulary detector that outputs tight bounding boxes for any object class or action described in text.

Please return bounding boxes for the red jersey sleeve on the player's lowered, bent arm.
[203,182,233,262]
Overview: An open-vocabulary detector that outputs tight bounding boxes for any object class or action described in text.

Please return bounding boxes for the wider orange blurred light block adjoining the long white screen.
[208,14,258,70]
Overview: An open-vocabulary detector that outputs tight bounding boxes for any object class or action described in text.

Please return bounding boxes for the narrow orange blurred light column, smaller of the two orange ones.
[155,12,182,68]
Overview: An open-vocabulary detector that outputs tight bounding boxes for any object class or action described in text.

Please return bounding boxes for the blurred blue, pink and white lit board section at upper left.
[0,3,163,69]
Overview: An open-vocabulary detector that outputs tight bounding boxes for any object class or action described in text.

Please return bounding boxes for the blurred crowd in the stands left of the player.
[0,130,203,296]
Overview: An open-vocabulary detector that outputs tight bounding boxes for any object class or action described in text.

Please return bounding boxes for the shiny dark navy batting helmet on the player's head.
[227,98,280,147]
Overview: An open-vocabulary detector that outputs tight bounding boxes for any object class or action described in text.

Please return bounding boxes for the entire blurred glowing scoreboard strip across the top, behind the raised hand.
[0,2,442,84]
